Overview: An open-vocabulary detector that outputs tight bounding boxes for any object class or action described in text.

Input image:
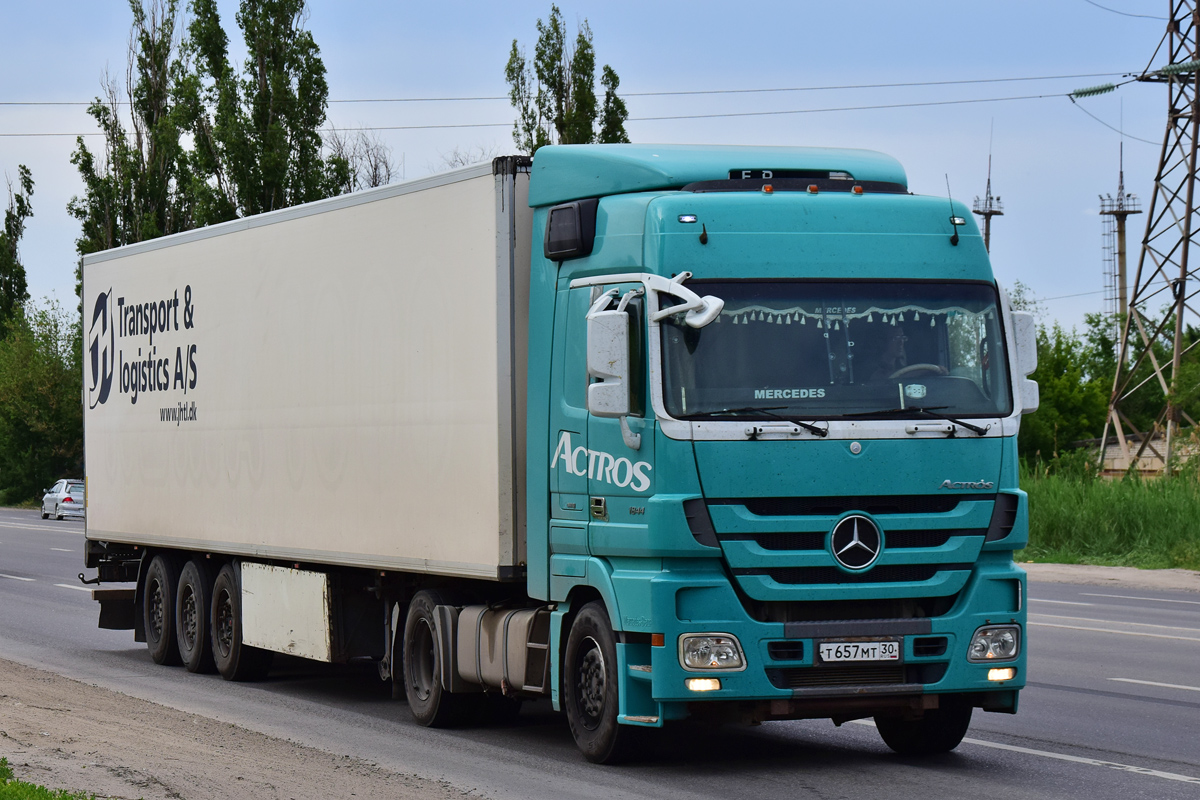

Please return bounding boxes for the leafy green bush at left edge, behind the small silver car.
[0,302,83,503]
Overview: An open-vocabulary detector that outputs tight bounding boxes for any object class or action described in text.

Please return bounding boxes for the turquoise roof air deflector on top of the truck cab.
[529,144,908,207]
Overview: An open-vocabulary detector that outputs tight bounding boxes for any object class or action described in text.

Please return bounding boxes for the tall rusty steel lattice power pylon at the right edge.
[1100,0,1200,473]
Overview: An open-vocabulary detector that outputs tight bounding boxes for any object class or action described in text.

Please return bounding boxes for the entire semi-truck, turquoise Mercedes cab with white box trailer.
[83,145,1038,763]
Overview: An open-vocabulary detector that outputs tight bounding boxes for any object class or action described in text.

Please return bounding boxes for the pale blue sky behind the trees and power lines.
[0,0,1168,326]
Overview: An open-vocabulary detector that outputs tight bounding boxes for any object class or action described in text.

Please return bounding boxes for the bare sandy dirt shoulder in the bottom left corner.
[0,660,477,800]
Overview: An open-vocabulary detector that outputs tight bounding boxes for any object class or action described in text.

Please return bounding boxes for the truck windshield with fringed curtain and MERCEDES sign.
[662,281,1012,420]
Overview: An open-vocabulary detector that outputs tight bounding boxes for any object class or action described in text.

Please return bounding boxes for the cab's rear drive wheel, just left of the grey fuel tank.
[401,589,484,728]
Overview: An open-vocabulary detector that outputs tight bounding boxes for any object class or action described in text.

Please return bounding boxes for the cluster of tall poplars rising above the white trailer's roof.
[68,0,360,286]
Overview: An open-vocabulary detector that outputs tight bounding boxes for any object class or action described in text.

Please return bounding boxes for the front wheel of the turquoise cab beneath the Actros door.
[563,602,634,764]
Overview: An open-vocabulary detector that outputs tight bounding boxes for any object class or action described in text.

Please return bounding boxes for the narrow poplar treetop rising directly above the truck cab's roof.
[504,5,629,154]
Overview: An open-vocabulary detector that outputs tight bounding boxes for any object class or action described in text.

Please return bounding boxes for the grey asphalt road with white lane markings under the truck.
[0,509,1200,800]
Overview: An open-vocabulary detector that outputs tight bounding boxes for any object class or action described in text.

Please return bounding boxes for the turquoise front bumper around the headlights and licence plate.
[623,553,1026,718]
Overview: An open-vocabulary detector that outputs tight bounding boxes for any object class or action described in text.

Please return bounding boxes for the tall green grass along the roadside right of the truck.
[1016,451,1200,570]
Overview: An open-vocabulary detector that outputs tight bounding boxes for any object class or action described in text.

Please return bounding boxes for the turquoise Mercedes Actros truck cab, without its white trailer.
[527,145,1037,762]
